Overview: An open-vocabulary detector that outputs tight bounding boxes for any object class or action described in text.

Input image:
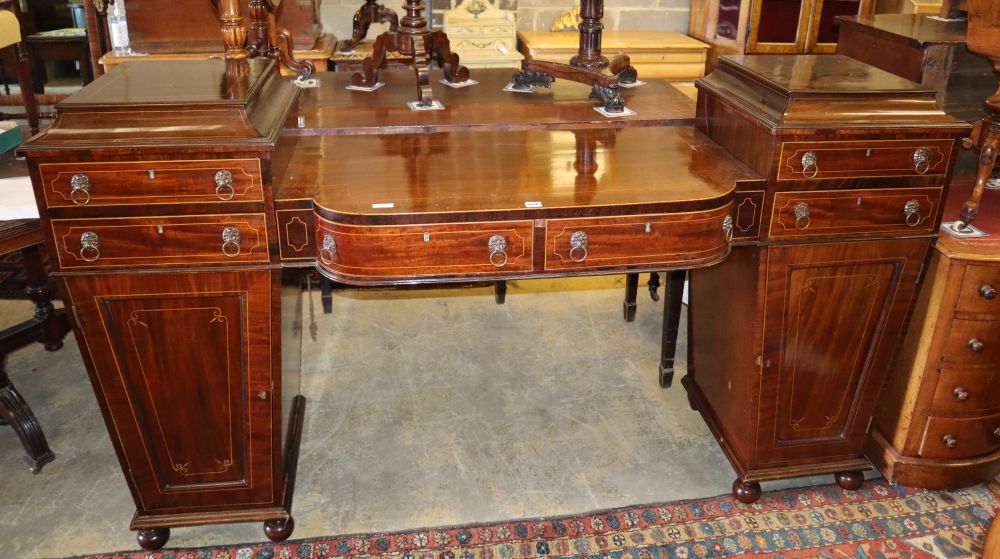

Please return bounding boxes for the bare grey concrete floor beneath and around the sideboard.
[0,276,844,559]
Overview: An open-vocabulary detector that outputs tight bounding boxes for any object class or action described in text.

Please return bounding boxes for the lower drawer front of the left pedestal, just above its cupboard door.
[52,214,269,270]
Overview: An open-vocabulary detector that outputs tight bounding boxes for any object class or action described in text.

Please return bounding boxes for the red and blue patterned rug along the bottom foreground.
[74,480,1000,559]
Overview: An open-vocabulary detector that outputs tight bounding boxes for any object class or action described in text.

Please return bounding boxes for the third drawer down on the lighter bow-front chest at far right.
[931,369,1000,416]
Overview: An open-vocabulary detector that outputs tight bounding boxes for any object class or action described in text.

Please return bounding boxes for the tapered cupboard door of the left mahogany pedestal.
[65,270,277,512]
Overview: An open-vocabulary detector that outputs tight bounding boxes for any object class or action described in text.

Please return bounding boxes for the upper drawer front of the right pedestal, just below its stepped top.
[778,140,954,181]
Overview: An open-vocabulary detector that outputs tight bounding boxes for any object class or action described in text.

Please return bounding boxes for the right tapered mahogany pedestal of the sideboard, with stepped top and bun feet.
[683,55,970,503]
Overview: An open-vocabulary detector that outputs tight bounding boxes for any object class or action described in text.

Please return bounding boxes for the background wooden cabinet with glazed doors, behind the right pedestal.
[688,0,874,72]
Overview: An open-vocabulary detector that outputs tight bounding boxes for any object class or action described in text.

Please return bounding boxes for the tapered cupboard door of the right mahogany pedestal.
[757,239,929,462]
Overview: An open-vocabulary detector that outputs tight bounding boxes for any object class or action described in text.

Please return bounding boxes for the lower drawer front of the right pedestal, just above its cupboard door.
[768,188,941,238]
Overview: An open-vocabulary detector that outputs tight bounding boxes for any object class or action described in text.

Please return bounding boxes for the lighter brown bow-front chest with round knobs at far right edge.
[866,187,1000,489]
